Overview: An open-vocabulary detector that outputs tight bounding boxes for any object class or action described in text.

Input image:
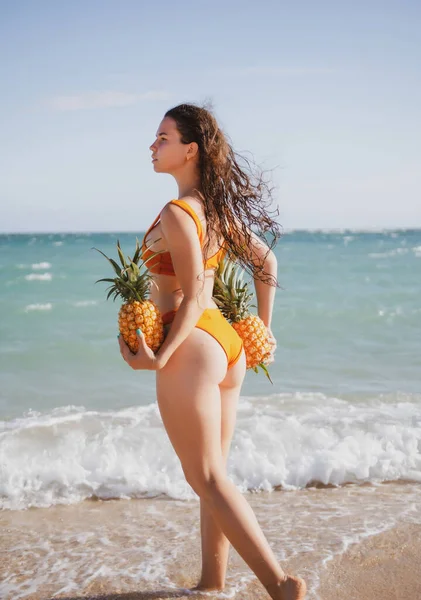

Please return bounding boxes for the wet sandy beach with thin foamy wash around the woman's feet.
[0,483,421,600]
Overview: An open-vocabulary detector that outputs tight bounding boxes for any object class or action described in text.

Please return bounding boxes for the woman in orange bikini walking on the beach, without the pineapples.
[119,104,306,600]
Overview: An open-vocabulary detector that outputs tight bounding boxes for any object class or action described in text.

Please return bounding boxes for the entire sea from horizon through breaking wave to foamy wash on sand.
[0,230,421,599]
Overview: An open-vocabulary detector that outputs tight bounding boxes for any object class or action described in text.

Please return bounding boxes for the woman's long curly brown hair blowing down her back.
[165,104,281,286]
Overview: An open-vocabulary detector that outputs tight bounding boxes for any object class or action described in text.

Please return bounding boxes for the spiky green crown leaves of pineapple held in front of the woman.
[92,238,162,302]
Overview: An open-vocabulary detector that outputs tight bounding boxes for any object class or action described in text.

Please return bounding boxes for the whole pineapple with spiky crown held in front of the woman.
[94,238,164,353]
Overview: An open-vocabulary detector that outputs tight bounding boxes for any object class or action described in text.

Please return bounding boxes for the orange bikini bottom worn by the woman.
[162,308,243,369]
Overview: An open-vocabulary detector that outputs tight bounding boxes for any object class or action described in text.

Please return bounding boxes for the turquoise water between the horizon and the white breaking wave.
[0,231,421,418]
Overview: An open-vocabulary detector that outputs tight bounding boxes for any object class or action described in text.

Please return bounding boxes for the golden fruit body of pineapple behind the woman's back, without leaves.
[231,314,270,369]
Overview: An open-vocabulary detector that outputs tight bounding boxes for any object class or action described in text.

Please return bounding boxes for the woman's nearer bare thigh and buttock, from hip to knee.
[157,329,227,479]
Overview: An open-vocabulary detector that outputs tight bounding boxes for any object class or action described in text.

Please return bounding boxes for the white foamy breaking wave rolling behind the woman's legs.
[0,394,421,509]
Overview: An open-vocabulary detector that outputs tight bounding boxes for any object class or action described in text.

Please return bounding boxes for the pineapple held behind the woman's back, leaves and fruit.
[213,259,272,382]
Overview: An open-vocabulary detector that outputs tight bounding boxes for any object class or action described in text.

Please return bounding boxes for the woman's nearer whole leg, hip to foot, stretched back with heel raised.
[157,329,305,600]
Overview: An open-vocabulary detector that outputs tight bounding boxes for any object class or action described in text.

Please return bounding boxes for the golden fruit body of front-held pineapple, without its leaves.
[118,300,164,353]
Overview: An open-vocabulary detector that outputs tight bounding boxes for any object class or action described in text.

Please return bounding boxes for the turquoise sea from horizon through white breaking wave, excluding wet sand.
[0,231,421,507]
